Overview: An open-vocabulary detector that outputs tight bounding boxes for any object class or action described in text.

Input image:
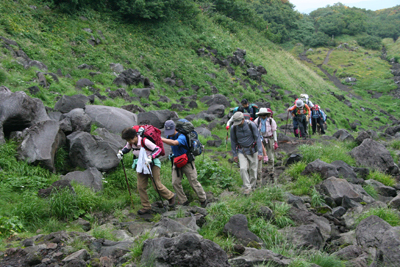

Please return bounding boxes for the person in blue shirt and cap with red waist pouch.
[161,120,208,208]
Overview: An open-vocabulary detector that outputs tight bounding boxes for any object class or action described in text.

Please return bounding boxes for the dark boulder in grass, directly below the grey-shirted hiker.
[224,214,261,246]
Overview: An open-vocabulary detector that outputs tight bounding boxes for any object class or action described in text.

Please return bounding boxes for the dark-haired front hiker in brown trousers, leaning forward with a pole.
[117,128,175,215]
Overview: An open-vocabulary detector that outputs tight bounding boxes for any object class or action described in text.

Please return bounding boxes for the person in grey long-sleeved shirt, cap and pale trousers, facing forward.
[231,112,263,195]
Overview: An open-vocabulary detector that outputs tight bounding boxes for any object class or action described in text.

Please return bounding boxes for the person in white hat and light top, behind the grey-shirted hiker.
[254,108,278,185]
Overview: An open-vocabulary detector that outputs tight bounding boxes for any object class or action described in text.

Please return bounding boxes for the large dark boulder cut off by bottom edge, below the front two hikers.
[141,233,230,267]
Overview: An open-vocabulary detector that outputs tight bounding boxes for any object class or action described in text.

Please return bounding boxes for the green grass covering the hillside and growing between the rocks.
[0,0,399,266]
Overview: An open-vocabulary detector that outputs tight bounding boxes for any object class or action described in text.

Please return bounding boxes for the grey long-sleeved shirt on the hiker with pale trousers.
[231,120,263,157]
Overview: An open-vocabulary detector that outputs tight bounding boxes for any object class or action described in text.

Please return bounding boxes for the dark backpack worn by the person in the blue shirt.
[175,119,204,157]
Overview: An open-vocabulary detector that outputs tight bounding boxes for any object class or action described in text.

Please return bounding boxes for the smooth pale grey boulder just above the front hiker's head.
[85,105,137,134]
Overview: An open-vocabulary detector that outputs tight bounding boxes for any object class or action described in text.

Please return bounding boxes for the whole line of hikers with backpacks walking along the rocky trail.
[117,95,326,215]
